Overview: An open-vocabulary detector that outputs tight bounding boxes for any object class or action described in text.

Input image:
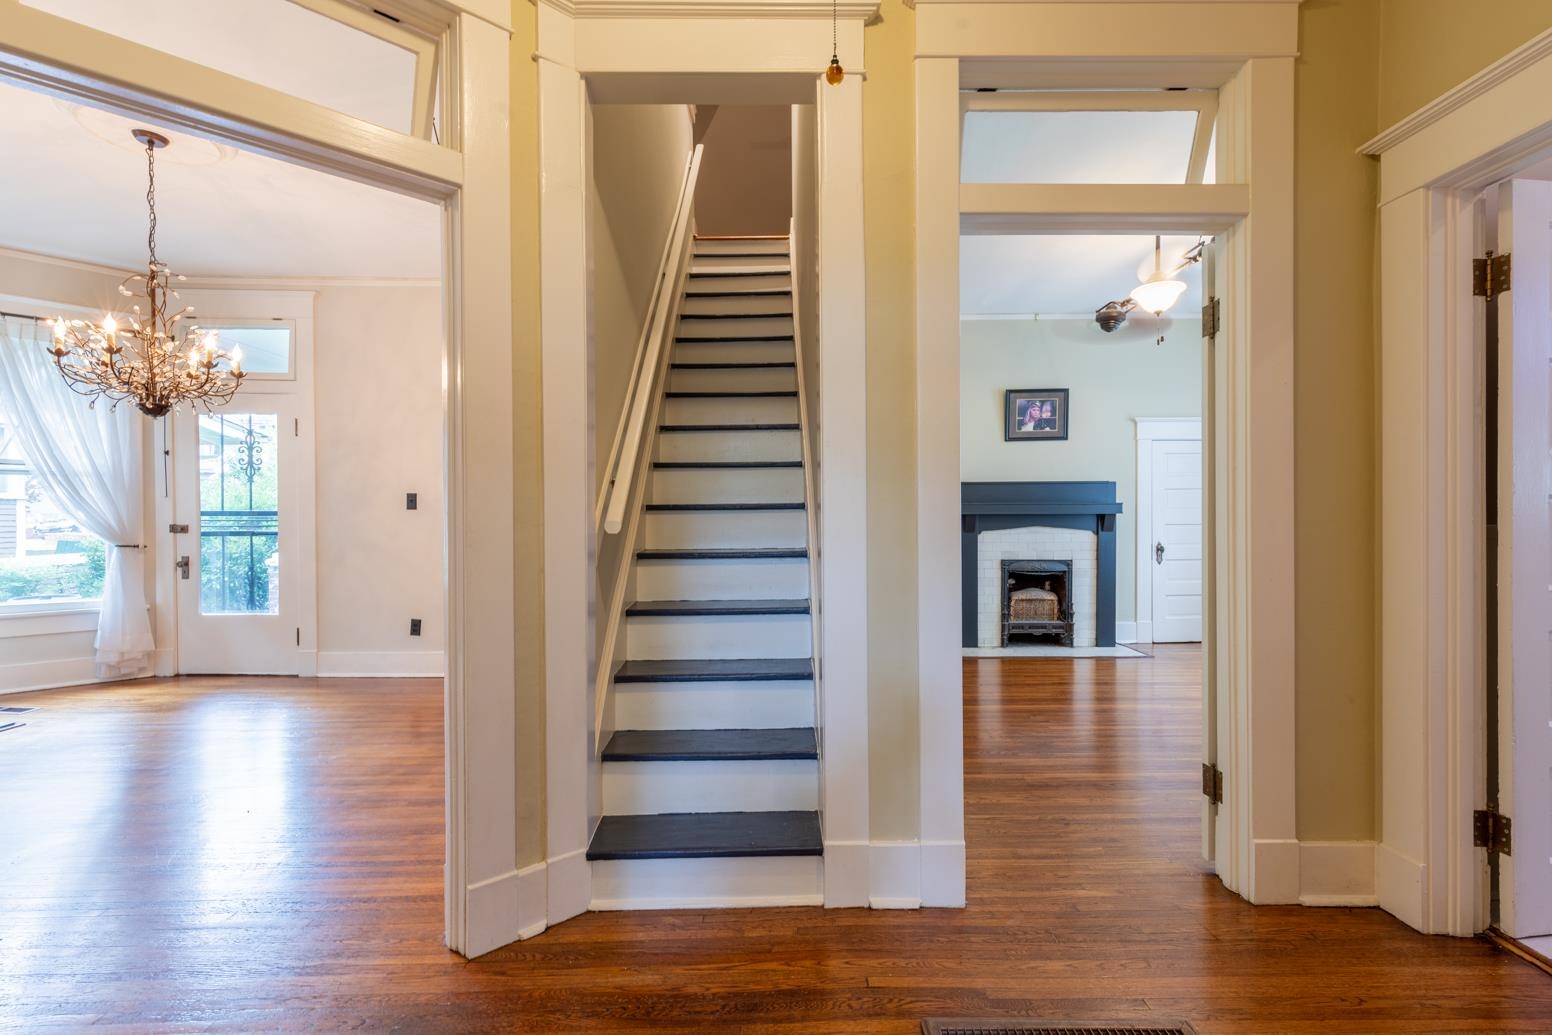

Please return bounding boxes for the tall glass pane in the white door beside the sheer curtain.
[199,413,281,614]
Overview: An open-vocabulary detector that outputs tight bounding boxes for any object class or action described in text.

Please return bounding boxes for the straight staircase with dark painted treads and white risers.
[588,237,823,909]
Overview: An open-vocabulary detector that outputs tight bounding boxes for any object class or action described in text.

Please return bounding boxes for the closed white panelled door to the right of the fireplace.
[1150,439,1203,644]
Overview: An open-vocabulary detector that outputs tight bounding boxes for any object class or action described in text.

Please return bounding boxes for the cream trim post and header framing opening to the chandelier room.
[0,0,535,956]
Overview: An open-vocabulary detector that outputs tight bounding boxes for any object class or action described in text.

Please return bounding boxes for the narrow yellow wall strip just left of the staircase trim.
[509,8,545,866]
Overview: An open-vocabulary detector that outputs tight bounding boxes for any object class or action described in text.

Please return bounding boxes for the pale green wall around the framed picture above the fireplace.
[959,320,1201,622]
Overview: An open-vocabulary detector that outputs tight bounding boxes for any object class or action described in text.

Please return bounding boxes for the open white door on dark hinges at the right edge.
[1498,180,1552,937]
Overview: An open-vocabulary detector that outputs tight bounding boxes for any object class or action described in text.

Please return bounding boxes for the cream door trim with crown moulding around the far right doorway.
[1363,31,1552,936]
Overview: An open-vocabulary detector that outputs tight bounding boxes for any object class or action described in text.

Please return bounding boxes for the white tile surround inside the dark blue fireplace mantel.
[976,526,1099,647]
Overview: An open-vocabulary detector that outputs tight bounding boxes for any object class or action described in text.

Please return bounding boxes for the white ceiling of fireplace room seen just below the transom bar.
[959,234,1201,317]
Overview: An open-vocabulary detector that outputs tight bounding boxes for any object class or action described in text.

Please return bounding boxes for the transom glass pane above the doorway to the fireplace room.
[959,112,1197,183]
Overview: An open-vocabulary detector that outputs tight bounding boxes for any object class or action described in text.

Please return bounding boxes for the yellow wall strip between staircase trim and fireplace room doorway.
[863,0,918,841]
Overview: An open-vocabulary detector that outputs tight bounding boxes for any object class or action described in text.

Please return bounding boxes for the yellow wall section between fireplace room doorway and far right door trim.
[1294,0,1380,841]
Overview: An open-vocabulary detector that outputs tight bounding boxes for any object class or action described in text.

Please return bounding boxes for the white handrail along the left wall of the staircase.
[604,144,702,535]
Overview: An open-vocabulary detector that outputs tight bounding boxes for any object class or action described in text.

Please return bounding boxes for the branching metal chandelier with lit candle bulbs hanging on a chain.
[48,129,244,417]
